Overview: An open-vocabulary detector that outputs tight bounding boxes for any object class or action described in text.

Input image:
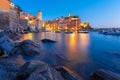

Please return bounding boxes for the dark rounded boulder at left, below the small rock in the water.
[12,40,40,56]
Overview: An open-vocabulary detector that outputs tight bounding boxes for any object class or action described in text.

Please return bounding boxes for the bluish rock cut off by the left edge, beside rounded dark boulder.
[0,36,15,56]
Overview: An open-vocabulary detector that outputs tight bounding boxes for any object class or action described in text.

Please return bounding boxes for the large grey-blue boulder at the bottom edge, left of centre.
[16,61,64,80]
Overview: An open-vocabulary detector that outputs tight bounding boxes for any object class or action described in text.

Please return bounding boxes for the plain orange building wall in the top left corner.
[0,0,11,11]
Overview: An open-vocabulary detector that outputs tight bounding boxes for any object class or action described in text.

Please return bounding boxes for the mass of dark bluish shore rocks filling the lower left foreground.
[0,36,81,80]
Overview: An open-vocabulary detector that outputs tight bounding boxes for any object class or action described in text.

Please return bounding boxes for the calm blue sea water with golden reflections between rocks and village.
[22,32,120,79]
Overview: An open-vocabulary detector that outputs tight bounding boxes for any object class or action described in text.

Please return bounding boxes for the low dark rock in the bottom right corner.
[90,69,120,80]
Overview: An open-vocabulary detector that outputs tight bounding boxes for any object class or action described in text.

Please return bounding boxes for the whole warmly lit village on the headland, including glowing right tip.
[44,14,90,31]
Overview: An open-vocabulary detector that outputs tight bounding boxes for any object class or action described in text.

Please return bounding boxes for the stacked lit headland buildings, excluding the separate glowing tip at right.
[42,14,81,30]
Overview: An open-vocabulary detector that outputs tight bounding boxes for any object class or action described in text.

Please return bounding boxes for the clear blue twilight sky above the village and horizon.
[12,0,120,28]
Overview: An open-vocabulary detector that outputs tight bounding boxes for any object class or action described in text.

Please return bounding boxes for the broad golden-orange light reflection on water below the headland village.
[67,33,89,61]
